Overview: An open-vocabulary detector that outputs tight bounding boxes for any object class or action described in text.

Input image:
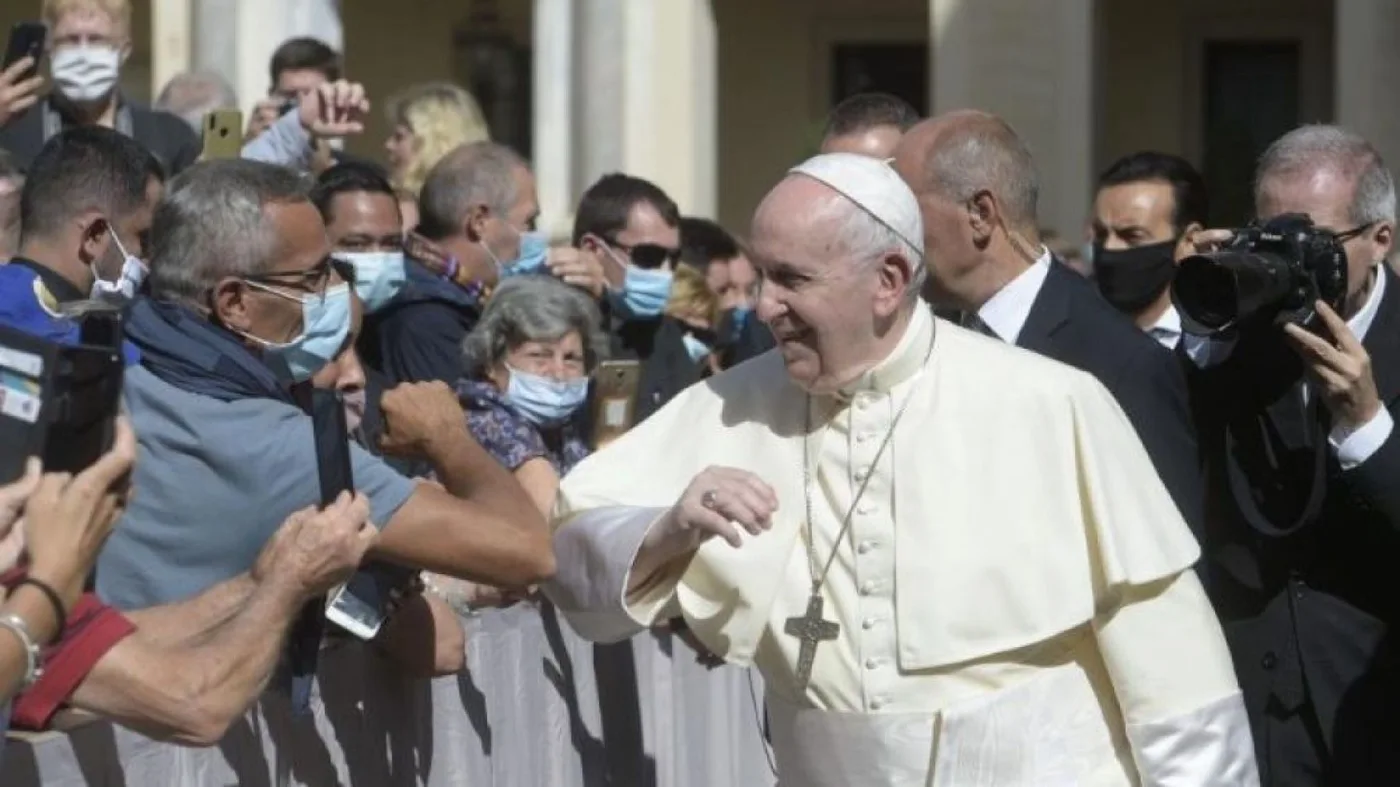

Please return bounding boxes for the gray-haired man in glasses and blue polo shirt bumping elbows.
[98,160,553,660]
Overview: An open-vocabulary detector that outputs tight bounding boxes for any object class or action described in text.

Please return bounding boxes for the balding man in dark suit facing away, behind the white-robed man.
[895,111,1203,538]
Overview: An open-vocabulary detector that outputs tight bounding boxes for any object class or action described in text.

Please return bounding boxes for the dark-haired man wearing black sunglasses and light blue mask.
[574,174,701,423]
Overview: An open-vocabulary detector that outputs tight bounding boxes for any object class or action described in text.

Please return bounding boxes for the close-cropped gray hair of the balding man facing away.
[927,115,1040,228]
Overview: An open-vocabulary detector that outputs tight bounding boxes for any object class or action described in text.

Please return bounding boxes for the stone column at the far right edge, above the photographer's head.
[1333,0,1400,172]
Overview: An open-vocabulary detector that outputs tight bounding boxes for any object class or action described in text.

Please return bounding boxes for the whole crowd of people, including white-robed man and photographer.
[0,0,1400,787]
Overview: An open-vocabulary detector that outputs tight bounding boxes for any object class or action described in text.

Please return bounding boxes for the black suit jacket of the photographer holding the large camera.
[1191,266,1400,784]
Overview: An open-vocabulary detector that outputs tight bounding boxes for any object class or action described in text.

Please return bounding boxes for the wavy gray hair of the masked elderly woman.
[462,276,608,378]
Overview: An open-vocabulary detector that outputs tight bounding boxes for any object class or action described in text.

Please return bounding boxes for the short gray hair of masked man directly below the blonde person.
[419,141,529,239]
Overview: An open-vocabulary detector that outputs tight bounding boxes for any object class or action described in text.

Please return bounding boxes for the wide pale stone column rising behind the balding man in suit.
[928,0,1095,238]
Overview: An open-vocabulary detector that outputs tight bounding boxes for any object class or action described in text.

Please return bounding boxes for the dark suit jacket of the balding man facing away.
[1016,262,1204,541]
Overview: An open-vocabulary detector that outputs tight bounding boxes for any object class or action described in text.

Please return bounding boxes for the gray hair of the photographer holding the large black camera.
[1254,123,1396,230]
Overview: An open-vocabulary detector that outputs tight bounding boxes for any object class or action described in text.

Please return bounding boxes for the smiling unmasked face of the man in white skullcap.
[752,176,911,394]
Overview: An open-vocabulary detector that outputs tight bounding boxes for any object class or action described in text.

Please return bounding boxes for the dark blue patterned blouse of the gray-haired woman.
[456,379,588,478]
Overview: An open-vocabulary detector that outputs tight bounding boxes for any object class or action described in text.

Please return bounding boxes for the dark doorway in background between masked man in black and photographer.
[1204,41,1302,227]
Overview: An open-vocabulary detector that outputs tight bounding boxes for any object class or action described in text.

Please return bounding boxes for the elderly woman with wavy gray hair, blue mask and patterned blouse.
[458,276,608,515]
